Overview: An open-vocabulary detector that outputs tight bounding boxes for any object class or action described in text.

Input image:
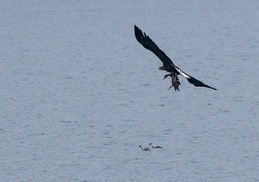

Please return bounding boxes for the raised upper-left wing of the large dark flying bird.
[134,25,174,66]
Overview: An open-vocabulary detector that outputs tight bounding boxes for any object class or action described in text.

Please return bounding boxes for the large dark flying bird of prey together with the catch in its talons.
[134,25,217,91]
